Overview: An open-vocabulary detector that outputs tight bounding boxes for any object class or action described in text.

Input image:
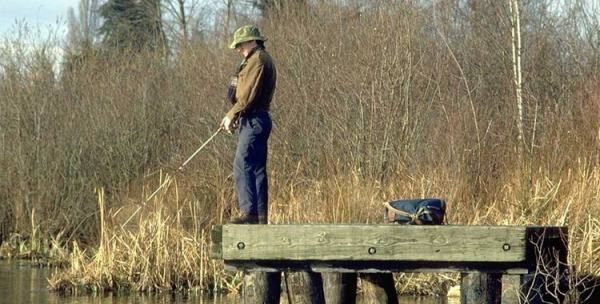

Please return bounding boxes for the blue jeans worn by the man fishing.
[233,112,272,216]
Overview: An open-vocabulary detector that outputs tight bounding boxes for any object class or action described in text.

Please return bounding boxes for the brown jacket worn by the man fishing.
[227,49,277,120]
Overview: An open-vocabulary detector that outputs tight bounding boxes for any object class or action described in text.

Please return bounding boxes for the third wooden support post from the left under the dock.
[322,272,358,304]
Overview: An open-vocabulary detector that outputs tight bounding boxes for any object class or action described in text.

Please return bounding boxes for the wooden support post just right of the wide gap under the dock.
[460,272,502,304]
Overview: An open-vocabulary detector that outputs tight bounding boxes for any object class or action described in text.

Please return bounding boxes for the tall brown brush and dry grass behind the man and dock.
[0,1,600,296]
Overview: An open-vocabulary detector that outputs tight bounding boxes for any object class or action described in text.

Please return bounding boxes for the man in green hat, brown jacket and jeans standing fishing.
[221,25,277,224]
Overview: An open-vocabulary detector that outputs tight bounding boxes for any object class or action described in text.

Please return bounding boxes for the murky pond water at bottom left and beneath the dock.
[0,260,458,304]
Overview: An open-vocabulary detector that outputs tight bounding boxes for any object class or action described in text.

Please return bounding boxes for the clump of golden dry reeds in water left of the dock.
[49,175,227,294]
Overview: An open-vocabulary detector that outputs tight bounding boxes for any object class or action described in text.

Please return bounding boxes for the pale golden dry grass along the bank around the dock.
[45,164,600,294]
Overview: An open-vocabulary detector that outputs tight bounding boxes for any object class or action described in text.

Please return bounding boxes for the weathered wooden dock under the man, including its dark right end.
[211,224,567,303]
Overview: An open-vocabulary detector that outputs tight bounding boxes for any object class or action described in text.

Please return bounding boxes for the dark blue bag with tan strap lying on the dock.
[384,198,446,225]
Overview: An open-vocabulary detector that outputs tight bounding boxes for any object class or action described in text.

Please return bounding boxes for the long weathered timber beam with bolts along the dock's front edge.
[222,225,526,262]
